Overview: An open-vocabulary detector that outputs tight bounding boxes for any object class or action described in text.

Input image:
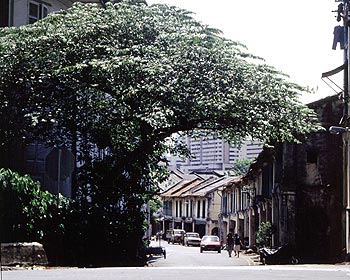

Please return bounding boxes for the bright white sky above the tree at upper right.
[147,0,344,103]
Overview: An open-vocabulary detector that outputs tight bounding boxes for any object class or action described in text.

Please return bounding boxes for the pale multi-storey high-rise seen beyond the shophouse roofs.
[169,135,263,173]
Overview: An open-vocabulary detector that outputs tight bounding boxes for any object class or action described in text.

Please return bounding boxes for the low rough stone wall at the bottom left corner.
[1,242,48,266]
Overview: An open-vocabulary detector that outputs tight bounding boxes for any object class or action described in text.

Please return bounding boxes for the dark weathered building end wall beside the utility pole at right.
[273,96,346,263]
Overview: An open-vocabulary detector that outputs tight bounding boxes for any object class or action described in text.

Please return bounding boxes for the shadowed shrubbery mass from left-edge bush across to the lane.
[0,167,149,266]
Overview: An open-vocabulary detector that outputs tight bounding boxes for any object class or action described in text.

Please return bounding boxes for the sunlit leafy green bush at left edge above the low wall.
[0,169,69,242]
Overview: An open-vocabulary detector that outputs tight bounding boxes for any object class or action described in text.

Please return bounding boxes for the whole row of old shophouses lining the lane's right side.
[158,93,346,263]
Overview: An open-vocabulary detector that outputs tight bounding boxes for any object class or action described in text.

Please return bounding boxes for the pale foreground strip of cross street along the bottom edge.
[2,265,350,280]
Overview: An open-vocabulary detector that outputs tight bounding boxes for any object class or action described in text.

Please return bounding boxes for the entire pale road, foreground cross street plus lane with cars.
[0,241,350,280]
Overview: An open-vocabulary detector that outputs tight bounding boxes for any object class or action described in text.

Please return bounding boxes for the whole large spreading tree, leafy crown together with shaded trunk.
[0,2,318,266]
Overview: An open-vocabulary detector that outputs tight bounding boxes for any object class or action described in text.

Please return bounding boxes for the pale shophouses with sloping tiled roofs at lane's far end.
[160,174,231,236]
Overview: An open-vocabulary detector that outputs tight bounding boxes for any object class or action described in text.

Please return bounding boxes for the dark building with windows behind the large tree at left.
[0,0,99,197]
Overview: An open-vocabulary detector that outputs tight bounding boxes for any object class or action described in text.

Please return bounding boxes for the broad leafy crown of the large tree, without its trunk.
[0,3,314,149]
